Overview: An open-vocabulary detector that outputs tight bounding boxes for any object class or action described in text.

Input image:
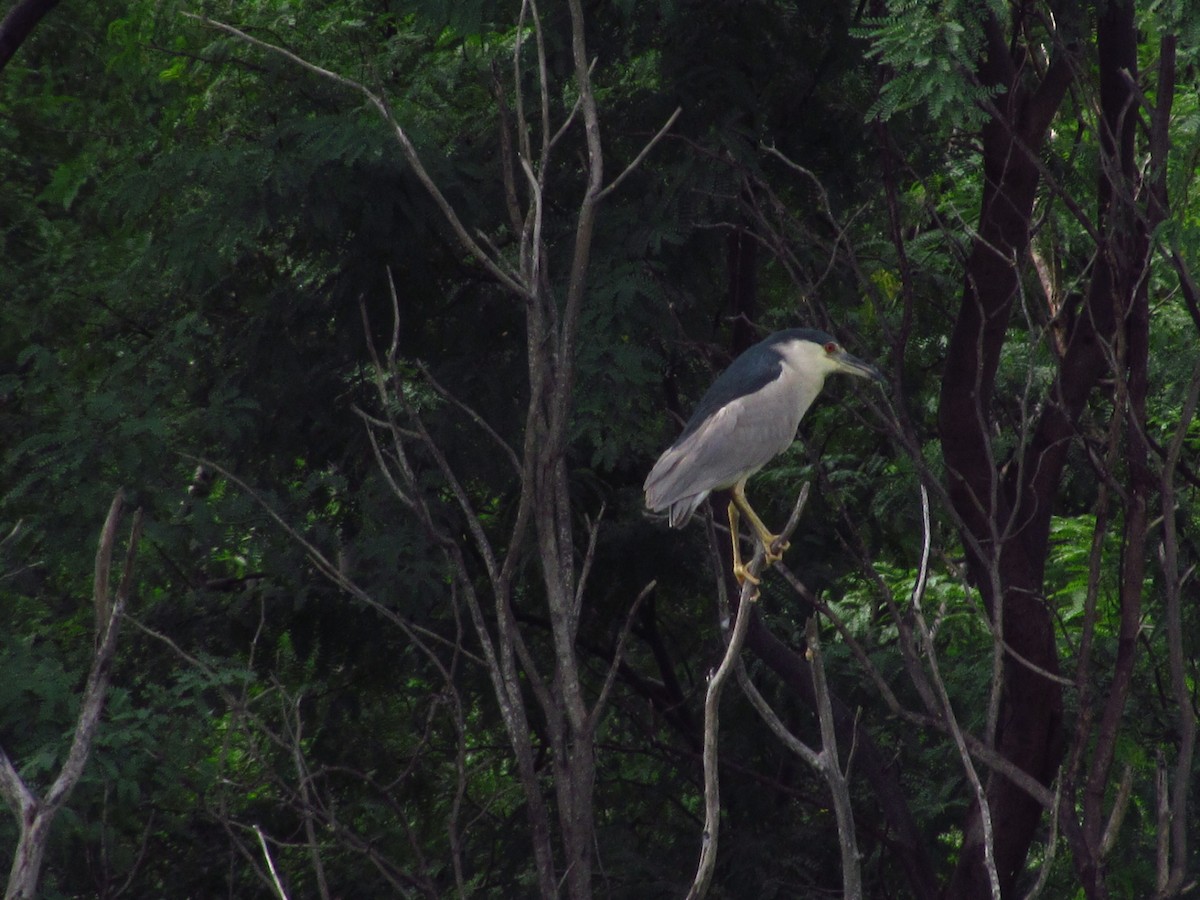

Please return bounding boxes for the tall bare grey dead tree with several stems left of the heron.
[181,8,676,900]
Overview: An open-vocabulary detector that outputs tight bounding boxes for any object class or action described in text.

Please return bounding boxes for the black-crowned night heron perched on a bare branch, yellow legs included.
[643,328,884,582]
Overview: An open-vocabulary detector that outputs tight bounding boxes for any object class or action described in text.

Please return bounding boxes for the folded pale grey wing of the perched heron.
[644,391,797,524]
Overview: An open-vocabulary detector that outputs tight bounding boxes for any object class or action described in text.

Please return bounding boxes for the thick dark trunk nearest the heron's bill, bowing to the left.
[938,10,1091,898]
